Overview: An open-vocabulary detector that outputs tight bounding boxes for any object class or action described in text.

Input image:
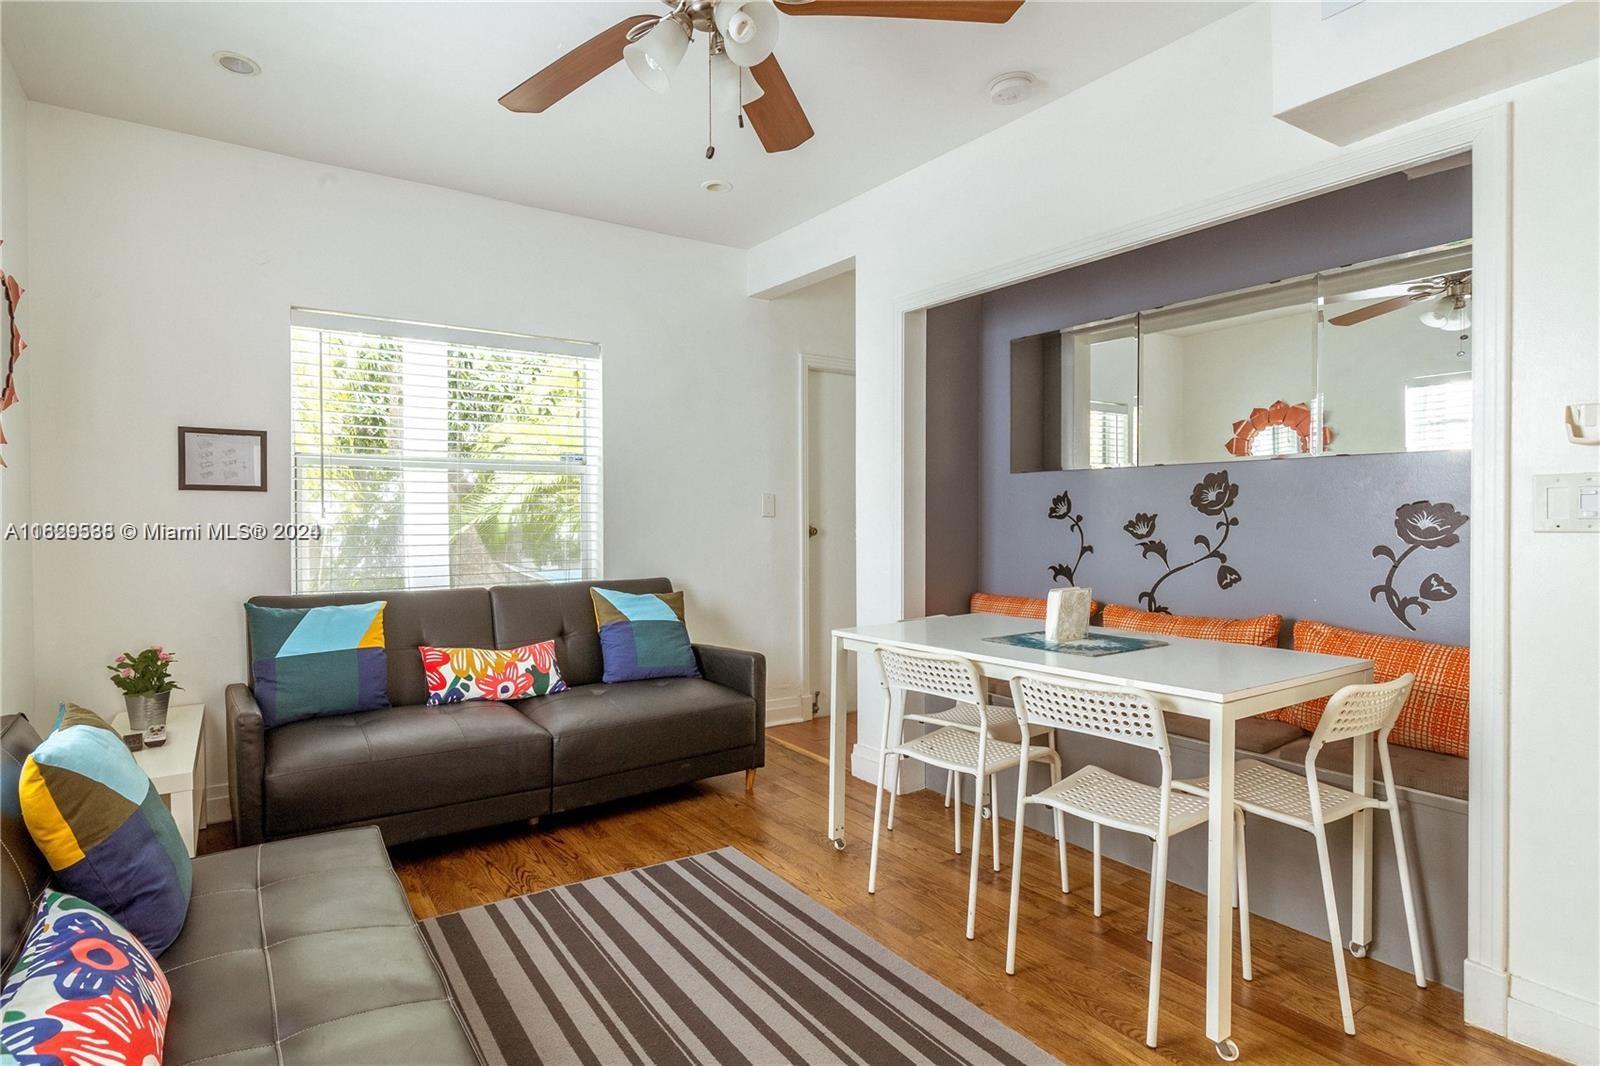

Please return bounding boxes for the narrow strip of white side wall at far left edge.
[0,53,34,725]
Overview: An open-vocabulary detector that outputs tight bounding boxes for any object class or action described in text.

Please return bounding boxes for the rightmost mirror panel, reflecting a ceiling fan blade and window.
[1317,245,1472,455]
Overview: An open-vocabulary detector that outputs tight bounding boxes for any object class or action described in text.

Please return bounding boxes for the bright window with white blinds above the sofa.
[290,311,600,592]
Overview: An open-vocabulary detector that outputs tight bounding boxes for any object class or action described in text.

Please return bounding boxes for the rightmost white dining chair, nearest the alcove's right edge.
[1176,674,1427,1036]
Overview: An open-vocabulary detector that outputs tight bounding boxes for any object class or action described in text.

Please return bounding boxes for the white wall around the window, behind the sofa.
[21,104,853,810]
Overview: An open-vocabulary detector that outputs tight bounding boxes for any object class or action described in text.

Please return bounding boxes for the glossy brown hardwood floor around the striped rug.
[368,723,1552,1064]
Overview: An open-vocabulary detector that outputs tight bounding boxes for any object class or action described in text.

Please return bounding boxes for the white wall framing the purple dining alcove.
[749,5,1600,1058]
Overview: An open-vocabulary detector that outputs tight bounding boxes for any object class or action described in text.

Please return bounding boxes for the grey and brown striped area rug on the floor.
[422,848,1056,1066]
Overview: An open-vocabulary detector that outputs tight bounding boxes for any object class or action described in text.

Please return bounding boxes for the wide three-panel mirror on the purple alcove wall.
[1011,242,1472,474]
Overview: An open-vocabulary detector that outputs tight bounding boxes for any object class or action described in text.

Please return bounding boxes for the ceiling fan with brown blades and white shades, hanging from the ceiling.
[499,0,1022,158]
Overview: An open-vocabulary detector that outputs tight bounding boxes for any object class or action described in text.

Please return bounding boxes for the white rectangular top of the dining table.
[834,615,1373,704]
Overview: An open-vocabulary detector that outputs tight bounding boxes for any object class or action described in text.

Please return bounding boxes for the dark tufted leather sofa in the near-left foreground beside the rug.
[0,715,482,1066]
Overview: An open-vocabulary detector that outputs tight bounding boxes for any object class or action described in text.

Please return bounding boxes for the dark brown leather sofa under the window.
[227,578,766,844]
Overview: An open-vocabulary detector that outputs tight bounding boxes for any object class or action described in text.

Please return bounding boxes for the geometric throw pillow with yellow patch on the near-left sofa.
[18,706,192,956]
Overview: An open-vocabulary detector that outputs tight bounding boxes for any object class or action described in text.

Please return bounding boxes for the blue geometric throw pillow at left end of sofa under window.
[245,600,389,728]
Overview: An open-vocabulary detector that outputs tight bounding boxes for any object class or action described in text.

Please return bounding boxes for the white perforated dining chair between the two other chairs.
[1005,674,1222,1047]
